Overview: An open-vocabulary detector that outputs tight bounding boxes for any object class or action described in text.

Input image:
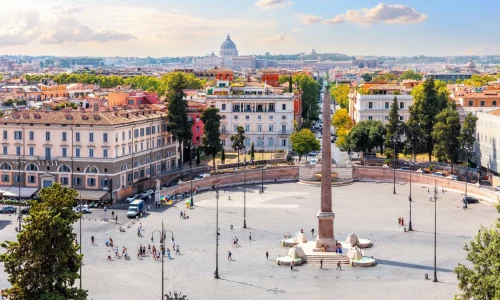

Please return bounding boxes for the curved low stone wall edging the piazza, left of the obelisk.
[160,166,299,196]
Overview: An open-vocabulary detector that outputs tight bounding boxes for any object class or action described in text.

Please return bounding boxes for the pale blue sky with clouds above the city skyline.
[0,0,500,57]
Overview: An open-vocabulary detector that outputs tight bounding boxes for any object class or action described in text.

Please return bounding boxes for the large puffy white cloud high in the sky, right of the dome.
[323,3,427,25]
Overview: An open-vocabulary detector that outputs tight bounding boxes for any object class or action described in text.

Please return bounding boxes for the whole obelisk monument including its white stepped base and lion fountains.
[276,83,376,266]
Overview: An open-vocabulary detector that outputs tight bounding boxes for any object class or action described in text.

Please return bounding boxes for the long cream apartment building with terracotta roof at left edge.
[0,108,179,200]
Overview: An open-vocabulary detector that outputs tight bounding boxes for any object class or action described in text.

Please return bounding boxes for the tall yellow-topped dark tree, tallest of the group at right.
[408,76,449,162]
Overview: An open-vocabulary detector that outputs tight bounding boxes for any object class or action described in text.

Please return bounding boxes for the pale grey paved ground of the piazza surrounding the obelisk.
[0,183,498,300]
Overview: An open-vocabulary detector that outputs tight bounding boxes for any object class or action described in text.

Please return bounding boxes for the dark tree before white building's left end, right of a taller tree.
[201,107,222,172]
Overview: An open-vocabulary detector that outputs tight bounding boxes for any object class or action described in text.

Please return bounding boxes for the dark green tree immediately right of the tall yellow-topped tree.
[432,102,460,172]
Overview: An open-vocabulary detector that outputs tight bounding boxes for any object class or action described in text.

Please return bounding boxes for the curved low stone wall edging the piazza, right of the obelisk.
[353,166,500,203]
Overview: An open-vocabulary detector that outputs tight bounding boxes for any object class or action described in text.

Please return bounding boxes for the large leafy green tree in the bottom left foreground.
[0,183,87,300]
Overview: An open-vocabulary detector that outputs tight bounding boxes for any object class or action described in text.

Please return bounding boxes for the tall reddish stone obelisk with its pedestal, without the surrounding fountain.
[316,82,336,251]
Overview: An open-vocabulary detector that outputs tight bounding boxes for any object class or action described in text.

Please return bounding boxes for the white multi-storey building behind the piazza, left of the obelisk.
[206,81,294,151]
